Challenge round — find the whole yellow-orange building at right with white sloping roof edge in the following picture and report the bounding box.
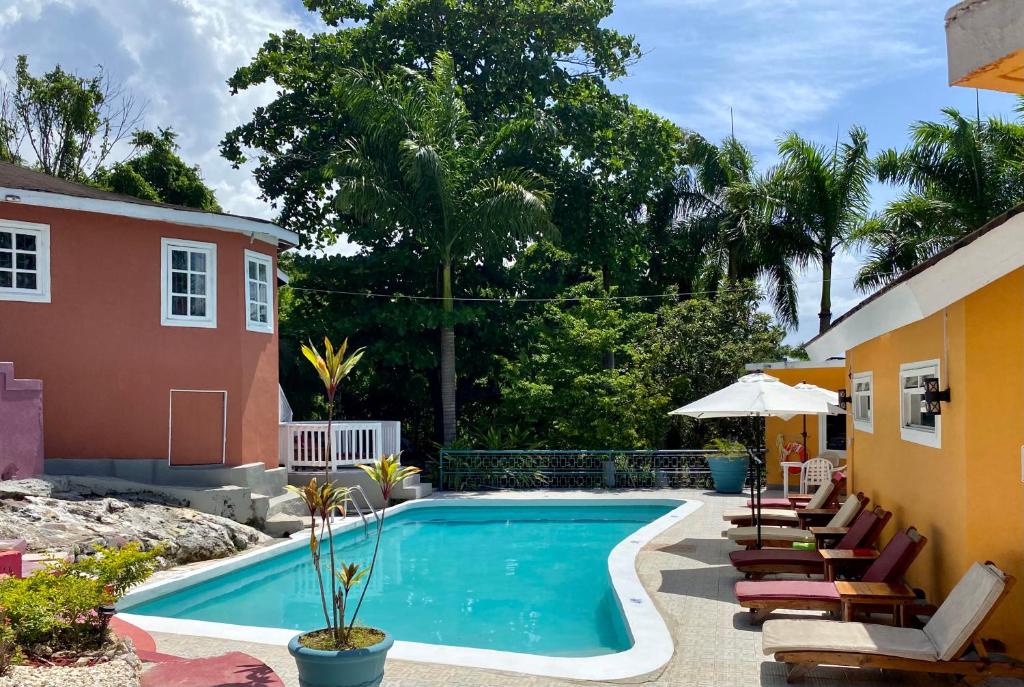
[807,208,1024,654]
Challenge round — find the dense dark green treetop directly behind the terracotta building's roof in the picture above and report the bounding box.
[94,129,220,212]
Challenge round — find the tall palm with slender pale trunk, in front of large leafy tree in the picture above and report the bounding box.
[332,52,553,445]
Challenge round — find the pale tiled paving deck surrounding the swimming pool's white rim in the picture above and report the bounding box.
[153,489,1021,687]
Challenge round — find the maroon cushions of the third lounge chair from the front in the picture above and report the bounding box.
[729,507,892,579]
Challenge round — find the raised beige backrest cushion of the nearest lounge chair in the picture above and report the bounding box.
[924,563,1007,660]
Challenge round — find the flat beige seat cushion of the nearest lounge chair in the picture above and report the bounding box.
[761,619,939,662]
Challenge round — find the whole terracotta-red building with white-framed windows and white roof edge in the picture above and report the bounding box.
[0,164,297,467]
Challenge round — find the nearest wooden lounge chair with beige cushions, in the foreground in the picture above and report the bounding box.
[761,563,1024,685]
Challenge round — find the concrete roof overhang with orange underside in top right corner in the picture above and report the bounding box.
[946,0,1024,93]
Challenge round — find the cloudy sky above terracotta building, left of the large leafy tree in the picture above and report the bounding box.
[0,0,317,218]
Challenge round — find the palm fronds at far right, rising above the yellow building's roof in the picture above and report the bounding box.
[856,107,1024,291]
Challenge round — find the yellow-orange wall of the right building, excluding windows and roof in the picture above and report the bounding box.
[847,270,1024,654]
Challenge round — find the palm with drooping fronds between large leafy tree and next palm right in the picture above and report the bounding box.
[677,134,809,327]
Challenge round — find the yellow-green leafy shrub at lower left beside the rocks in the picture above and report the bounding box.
[0,545,160,651]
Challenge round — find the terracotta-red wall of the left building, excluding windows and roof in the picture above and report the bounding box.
[0,203,278,467]
